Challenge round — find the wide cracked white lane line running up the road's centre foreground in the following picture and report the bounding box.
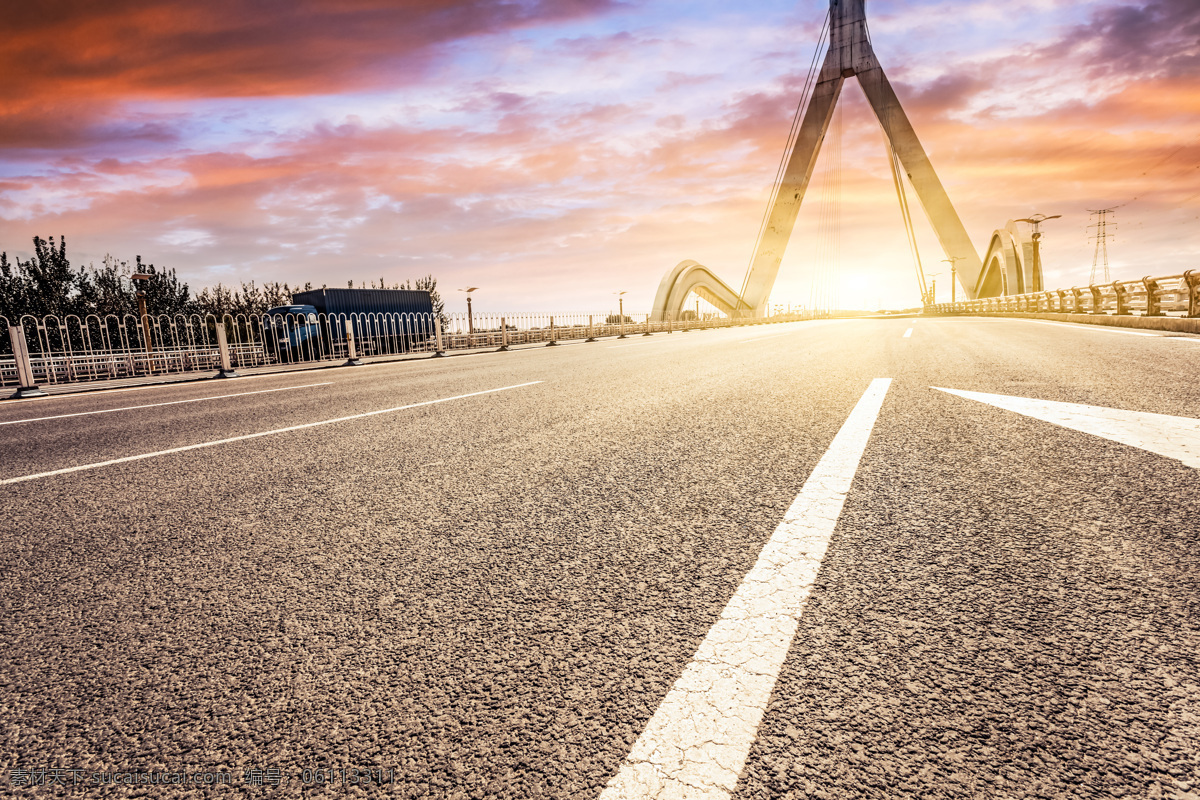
[600,378,892,800]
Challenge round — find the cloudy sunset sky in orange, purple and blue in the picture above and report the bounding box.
[0,0,1200,312]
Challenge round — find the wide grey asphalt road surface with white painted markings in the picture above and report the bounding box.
[0,318,1200,800]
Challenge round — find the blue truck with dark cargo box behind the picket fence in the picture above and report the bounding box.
[263,289,433,360]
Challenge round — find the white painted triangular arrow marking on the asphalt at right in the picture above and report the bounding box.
[930,386,1200,469]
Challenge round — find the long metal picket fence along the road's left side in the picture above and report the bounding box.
[0,313,812,387]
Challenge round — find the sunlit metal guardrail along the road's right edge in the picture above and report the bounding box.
[930,270,1200,317]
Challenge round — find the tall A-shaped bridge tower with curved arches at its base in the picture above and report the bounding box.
[654,0,1040,319]
